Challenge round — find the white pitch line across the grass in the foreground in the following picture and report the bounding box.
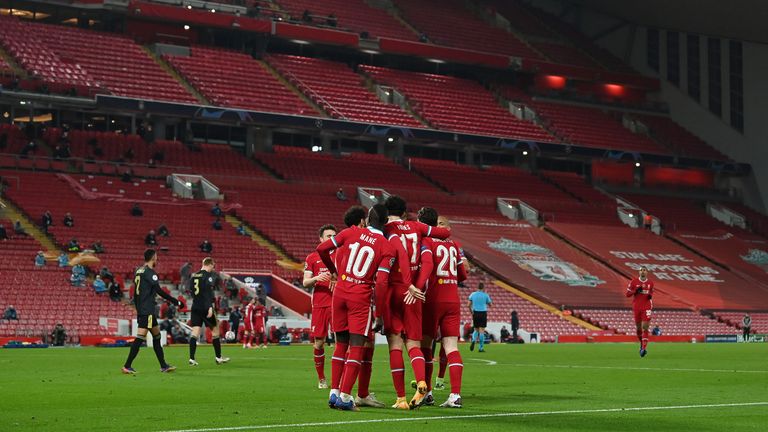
[158,402,768,432]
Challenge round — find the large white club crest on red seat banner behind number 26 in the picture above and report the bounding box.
[488,237,605,287]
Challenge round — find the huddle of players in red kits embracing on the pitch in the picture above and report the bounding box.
[304,196,466,410]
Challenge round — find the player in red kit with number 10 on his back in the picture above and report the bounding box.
[317,205,397,410]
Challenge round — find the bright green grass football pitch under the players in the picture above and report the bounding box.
[0,343,768,432]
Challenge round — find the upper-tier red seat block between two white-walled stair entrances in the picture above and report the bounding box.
[360,65,553,142]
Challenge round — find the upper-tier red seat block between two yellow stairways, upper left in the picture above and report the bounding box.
[164,46,312,116]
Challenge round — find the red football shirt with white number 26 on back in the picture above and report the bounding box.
[419,237,467,303]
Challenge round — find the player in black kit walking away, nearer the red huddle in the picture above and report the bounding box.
[189,257,229,366]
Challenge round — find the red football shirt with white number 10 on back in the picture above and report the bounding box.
[317,228,396,316]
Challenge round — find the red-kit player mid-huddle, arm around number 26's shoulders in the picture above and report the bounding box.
[384,195,451,409]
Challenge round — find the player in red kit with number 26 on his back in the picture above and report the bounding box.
[417,207,467,408]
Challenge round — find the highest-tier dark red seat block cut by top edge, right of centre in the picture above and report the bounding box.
[395,0,539,58]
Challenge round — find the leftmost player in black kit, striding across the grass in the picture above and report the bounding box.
[123,249,181,374]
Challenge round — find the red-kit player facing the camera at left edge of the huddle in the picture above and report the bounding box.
[303,225,336,389]
